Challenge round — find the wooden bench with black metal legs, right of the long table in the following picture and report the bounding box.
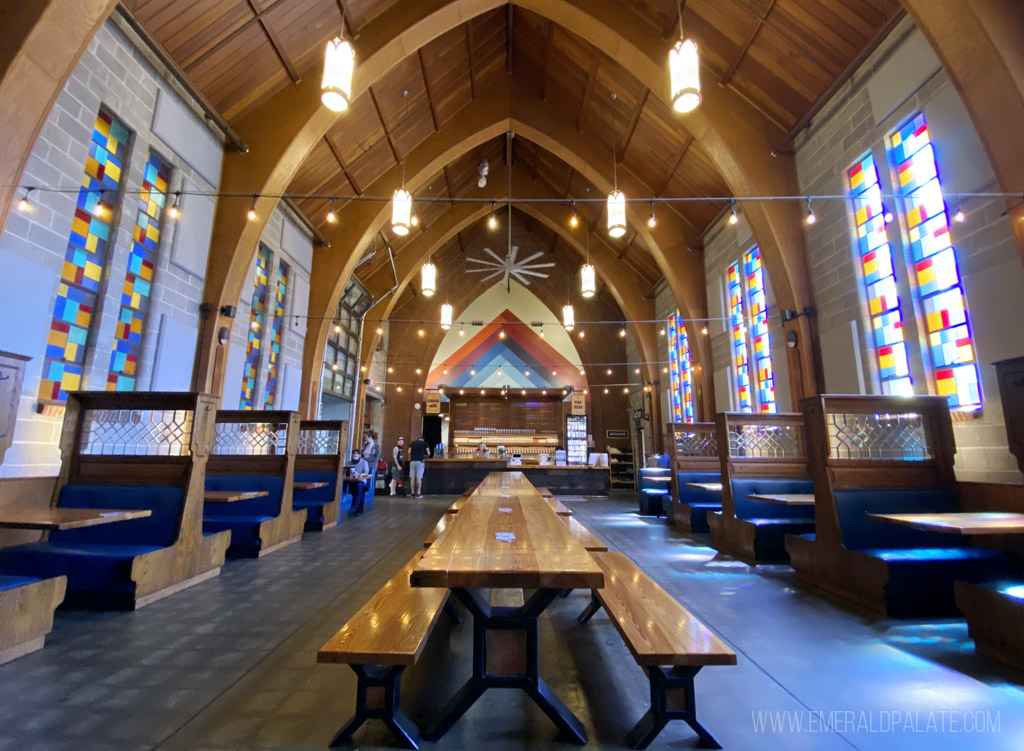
[578,552,736,748]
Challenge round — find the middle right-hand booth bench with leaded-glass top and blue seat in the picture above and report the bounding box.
[708,412,814,561]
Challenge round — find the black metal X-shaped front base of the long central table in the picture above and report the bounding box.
[424,589,587,745]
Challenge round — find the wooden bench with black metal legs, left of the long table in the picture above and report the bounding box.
[316,552,449,749]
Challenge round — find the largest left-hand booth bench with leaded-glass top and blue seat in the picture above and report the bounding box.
[29,391,229,610]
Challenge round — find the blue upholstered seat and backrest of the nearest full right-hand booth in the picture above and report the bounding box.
[834,489,1020,616]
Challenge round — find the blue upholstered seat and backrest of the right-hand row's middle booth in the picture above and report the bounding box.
[731,477,814,560]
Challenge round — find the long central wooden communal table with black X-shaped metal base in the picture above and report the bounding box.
[411,472,604,745]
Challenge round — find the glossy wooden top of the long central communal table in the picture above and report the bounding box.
[412,472,604,589]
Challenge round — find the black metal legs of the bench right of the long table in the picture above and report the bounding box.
[577,592,722,748]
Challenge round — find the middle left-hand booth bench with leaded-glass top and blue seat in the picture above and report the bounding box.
[203,410,306,557]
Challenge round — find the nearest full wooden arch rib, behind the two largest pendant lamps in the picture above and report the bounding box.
[192,0,820,397]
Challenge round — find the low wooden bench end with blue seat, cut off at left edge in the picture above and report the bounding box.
[0,575,68,665]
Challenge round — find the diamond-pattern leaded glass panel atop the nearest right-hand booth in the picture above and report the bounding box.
[825,413,934,461]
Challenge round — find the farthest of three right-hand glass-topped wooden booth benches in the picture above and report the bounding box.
[669,422,722,532]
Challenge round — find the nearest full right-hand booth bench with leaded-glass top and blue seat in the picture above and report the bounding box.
[786,395,1013,615]
